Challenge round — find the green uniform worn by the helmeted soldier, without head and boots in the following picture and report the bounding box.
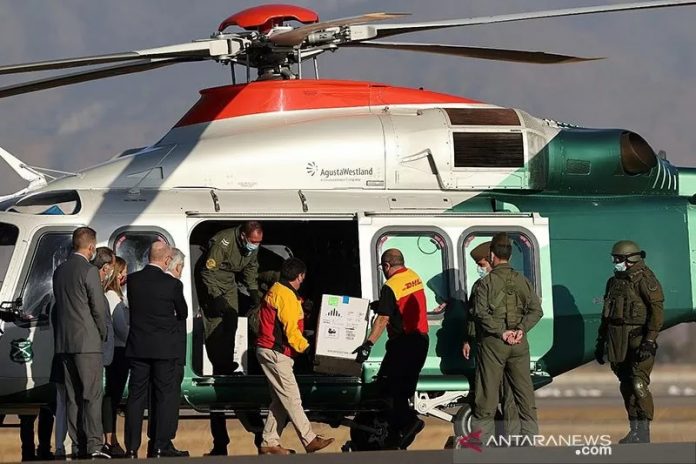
[597,261,664,421]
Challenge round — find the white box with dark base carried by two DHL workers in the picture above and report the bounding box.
[314,295,370,376]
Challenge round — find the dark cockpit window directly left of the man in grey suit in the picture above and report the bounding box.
[22,232,72,321]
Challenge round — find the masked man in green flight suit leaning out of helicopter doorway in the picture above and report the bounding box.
[201,221,263,456]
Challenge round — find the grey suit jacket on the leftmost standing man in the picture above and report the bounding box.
[53,253,108,354]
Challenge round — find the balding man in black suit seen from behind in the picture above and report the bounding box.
[125,242,188,457]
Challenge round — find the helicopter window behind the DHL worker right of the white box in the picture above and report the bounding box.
[376,231,449,314]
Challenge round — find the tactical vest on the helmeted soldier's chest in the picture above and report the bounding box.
[602,270,648,325]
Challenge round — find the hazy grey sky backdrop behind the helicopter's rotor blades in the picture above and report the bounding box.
[0,0,696,195]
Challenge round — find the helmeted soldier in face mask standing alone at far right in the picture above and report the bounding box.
[595,240,665,443]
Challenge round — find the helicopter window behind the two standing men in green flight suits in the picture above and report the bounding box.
[463,231,539,294]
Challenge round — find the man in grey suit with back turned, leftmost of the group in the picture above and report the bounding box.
[53,227,109,458]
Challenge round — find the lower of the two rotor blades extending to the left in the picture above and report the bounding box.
[0,57,201,98]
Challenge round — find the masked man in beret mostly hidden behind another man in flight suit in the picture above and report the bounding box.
[462,241,520,436]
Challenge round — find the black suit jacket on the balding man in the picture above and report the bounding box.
[126,265,188,359]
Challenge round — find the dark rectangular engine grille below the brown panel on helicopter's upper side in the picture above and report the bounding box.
[452,132,524,168]
